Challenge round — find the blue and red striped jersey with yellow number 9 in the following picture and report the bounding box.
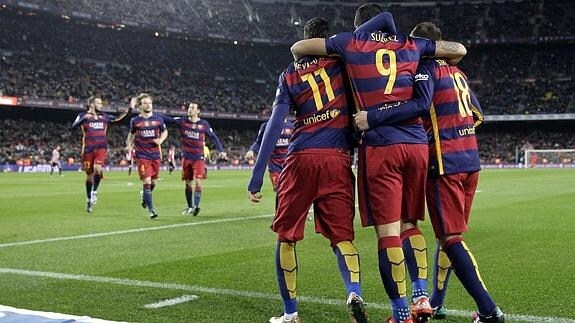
[326,31,435,146]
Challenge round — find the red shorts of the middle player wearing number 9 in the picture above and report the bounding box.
[358,144,428,227]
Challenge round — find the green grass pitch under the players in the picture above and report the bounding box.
[0,169,575,322]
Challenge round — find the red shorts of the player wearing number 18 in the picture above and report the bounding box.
[427,172,479,239]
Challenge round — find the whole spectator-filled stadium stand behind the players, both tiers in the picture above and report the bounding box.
[0,0,575,170]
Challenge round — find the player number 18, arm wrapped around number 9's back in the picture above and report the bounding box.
[358,22,505,323]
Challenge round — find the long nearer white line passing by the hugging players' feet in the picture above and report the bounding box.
[0,268,575,323]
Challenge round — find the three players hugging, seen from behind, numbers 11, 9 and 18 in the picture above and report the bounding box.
[246,4,505,323]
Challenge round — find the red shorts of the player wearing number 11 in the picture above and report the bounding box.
[271,149,355,244]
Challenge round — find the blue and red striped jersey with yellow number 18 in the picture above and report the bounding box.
[416,59,483,175]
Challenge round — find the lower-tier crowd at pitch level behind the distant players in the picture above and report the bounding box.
[0,119,575,166]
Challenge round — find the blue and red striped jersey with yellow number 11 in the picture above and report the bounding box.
[274,57,350,152]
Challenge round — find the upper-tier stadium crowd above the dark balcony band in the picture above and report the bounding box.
[0,1,575,114]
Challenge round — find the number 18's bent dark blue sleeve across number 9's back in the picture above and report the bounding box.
[367,60,435,128]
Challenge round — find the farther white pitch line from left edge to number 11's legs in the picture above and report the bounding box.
[0,214,273,248]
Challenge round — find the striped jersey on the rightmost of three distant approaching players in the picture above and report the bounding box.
[164,116,224,160]
